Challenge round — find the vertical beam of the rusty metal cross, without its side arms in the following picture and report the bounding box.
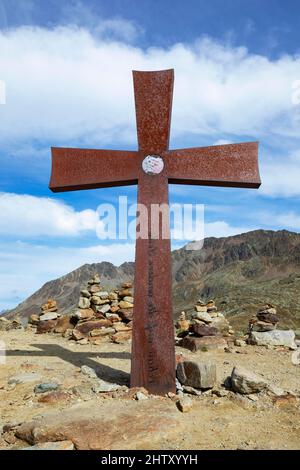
[130,70,176,395]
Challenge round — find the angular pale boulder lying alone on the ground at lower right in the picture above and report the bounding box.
[231,367,268,394]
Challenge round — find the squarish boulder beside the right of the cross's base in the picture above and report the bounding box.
[176,361,217,389]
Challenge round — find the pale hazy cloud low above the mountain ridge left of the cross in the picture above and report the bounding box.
[0,242,134,311]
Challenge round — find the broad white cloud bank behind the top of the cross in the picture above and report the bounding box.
[0,26,300,145]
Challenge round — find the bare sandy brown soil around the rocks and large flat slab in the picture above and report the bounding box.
[0,330,300,449]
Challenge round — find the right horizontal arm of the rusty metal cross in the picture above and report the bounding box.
[163,142,261,188]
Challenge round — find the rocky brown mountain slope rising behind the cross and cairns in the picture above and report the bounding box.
[7,230,300,330]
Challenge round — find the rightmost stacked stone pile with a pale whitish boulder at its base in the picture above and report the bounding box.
[248,303,297,349]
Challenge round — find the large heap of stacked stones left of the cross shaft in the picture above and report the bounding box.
[29,274,134,344]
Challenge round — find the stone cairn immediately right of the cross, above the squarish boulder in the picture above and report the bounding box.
[175,300,234,351]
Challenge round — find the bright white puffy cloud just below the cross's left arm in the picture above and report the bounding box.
[0,193,101,238]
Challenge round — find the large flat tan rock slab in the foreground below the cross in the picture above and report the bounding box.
[15,400,184,451]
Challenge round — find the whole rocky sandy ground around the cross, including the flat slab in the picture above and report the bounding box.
[0,329,300,449]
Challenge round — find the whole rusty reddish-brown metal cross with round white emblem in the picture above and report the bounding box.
[50,70,260,395]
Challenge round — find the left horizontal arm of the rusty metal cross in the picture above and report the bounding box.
[49,147,138,192]
